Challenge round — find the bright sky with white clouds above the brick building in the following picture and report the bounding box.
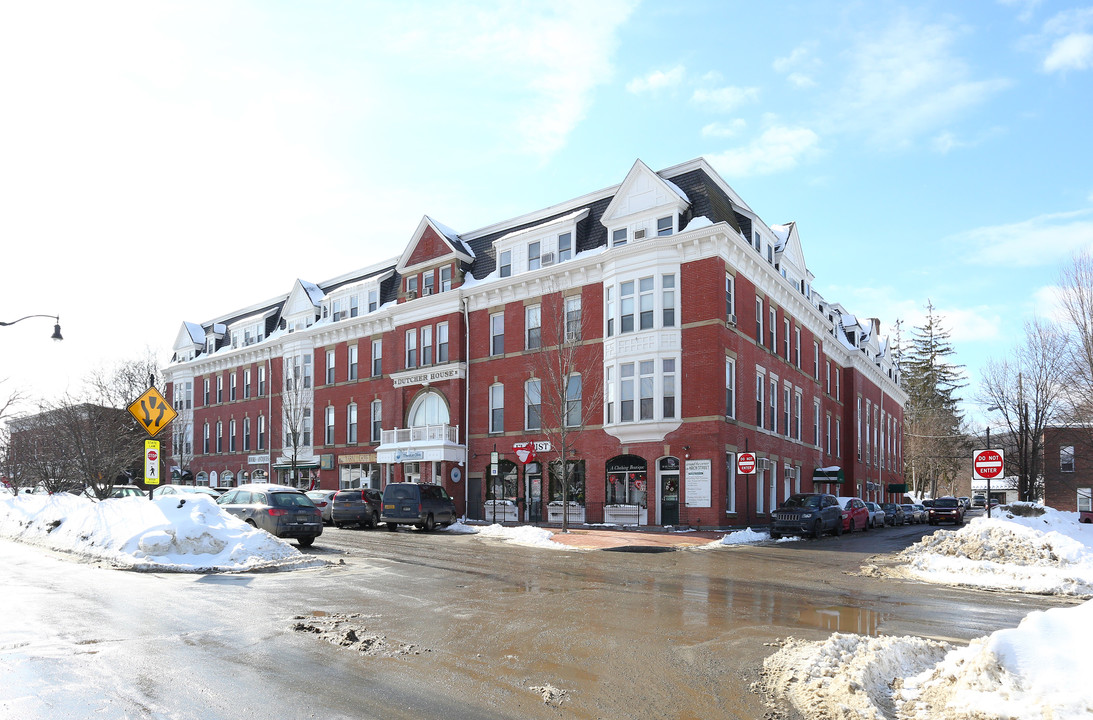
[0,0,1093,421]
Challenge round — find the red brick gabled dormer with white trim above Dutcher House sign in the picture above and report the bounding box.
[395,215,474,302]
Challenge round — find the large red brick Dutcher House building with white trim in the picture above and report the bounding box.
[166,160,906,527]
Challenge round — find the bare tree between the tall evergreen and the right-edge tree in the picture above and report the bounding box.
[977,320,1069,501]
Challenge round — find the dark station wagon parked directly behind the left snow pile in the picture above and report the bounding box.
[216,483,322,547]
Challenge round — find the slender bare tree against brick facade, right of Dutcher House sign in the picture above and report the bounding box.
[524,292,603,532]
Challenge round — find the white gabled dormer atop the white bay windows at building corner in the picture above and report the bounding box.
[600,160,691,247]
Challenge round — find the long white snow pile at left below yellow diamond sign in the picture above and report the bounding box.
[0,493,325,573]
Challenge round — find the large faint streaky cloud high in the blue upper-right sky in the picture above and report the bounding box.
[827,14,1010,147]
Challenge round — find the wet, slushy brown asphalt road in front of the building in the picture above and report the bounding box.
[0,509,1073,720]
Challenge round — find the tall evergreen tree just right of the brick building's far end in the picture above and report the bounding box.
[898,302,967,497]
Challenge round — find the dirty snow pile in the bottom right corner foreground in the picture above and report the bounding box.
[757,601,1093,720]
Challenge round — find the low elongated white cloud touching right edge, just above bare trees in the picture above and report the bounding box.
[948,210,1093,268]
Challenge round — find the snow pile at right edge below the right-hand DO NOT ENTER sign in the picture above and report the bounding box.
[889,503,1093,597]
